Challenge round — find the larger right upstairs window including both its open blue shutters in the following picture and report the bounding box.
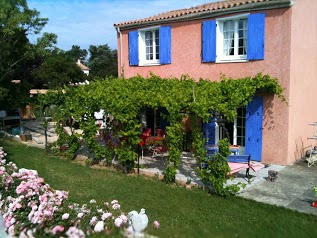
[202,13,265,62]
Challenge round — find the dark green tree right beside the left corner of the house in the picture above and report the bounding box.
[88,44,118,78]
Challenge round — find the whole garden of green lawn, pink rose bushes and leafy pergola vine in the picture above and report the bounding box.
[1,74,308,237]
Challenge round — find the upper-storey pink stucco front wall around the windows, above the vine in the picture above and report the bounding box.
[118,9,290,80]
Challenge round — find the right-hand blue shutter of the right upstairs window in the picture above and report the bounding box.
[247,13,265,60]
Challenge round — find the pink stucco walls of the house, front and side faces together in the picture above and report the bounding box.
[118,6,317,164]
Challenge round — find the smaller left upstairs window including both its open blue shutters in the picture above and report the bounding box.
[129,26,171,66]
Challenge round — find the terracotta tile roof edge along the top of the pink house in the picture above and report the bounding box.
[114,0,291,27]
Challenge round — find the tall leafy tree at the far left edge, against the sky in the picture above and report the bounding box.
[0,0,47,109]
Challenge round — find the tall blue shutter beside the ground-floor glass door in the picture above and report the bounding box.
[245,97,263,161]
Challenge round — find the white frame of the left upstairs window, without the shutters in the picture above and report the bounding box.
[139,26,160,66]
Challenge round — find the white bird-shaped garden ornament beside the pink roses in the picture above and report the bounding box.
[128,208,149,237]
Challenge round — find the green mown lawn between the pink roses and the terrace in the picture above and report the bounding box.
[0,139,317,238]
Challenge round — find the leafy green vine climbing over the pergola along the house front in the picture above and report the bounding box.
[42,74,285,190]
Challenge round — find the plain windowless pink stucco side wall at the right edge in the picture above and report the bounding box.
[288,0,317,163]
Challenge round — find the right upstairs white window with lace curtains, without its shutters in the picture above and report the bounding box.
[216,18,248,61]
